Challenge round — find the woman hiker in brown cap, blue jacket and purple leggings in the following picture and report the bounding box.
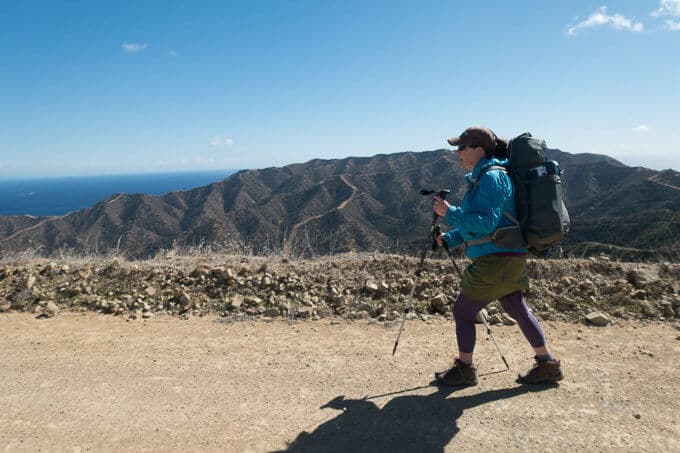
[434,127,564,386]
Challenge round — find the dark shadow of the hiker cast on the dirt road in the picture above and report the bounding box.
[274,386,552,452]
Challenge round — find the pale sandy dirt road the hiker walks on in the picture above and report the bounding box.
[0,313,680,451]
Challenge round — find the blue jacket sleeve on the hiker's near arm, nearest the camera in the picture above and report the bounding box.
[445,170,512,237]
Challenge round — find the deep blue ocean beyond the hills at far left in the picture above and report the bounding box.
[0,170,237,217]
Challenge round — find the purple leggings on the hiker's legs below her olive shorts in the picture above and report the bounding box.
[453,291,545,353]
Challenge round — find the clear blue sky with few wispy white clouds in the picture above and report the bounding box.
[0,0,680,179]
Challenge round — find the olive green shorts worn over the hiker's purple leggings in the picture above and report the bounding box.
[462,255,529,301]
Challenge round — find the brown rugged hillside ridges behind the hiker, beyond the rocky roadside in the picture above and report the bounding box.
[0,150,680,260]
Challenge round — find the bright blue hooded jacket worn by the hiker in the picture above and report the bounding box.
[444,157,527,259]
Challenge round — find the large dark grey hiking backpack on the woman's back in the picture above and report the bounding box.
[507,132,570,256]
